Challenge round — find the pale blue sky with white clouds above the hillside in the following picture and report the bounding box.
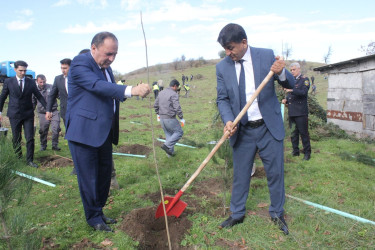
[0,0,375,83]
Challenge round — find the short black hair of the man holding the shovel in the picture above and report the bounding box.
[217,23,247,47]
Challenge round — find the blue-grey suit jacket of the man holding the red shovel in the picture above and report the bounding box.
[216,47,294,146]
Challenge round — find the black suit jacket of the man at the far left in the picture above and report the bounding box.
[0,77,47,119]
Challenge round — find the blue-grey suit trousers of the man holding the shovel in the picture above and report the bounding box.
[230,124,285,219]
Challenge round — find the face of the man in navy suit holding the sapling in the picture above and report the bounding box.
[91,38,118,68]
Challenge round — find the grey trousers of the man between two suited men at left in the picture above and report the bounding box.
[38,110,61,148]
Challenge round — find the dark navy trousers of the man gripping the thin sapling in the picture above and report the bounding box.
[69,132,112,226]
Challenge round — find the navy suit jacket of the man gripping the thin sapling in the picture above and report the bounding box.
[65,53,127,147]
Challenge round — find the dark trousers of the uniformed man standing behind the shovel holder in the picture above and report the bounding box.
[289,115,311,155]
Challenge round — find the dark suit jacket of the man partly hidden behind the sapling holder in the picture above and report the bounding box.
[47,74,68,120]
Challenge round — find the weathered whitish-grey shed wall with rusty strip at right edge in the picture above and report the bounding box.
[327,60,375,138]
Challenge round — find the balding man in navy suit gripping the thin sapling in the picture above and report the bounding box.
[65,32,151,232]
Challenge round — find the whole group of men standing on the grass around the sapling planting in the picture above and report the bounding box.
[0,23,311,234]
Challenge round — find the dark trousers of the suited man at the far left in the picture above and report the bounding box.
[9,116,35,162]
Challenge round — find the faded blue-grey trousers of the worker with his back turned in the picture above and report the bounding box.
[160,118,184,152]
